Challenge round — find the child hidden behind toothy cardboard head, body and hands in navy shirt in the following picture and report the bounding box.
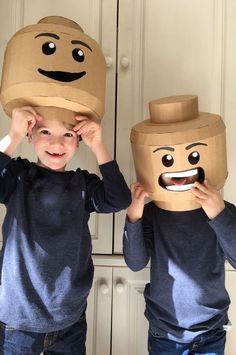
[123,181,236,355]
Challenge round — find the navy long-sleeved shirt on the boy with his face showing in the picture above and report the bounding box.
[0,153,130,333]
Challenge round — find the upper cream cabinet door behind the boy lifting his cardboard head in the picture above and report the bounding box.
[0,0,117,254]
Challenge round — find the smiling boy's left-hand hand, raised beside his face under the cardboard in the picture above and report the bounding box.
[9,106,41,139]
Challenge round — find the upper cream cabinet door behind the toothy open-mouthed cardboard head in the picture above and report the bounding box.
[115,0,229,253]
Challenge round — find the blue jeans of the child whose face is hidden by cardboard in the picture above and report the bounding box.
[148,328,226,355]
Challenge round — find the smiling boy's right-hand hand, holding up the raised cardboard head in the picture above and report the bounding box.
[73,116,102,149]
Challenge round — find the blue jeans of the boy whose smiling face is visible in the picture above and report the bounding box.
[0,315,87,355]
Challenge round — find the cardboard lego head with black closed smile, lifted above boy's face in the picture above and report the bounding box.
[1,16,106,124]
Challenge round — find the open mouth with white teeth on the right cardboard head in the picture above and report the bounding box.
[159,168,205,191]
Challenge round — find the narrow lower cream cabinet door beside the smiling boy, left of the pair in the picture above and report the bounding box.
[86,266,112,355]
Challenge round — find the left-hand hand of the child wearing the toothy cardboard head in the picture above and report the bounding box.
[127,182,148,223]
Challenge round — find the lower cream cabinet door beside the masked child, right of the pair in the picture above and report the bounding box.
[112,268,150,355]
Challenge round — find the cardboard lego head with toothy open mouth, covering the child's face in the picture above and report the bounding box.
[131,95,227,211]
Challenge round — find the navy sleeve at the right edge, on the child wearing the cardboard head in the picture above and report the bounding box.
[208,202,236,268]
